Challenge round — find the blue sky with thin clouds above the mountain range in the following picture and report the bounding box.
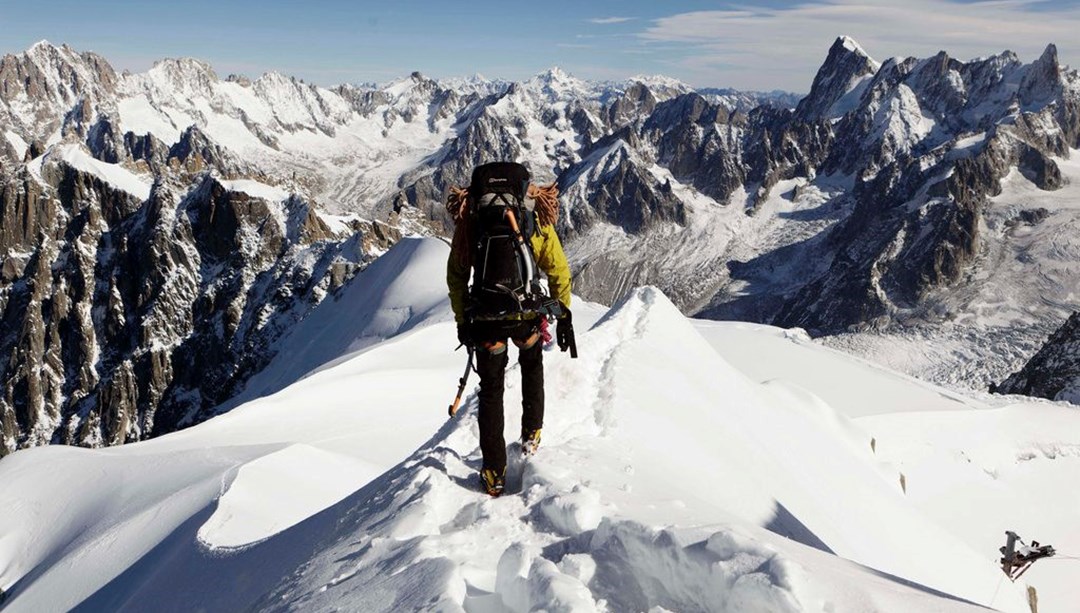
[0,0,1080,92]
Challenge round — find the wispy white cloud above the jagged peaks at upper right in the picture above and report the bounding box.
[639,0,1080,92]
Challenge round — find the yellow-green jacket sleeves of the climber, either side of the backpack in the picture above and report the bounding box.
[446,221,570,324]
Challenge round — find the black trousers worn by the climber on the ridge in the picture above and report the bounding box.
[473,322,543,473]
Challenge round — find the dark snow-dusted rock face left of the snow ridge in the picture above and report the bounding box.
[0,162,397,454]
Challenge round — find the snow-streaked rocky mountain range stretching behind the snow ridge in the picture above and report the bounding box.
[0,38,1080,454]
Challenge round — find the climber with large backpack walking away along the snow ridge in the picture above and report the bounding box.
[446,162,577,496]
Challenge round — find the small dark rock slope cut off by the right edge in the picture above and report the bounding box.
[990,313,1080,405]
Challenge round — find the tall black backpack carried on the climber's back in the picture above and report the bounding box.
[469,162,551,319]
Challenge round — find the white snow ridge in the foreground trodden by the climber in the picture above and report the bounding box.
[0,240,1080,612]
